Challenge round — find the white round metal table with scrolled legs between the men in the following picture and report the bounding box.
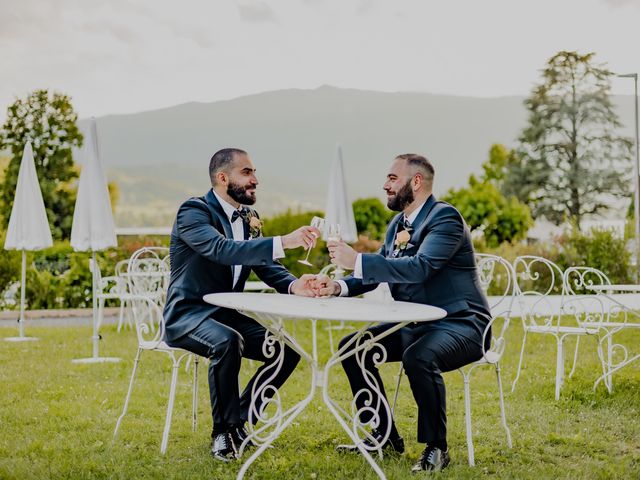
[204,293,446,479]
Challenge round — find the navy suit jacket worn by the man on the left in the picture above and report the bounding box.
[164,190,296,342]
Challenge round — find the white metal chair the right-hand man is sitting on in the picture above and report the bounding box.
[458,254,515,466]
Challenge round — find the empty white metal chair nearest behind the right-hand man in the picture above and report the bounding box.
[511,255,593,400]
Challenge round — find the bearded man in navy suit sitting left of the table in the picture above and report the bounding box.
[164,148,320,461]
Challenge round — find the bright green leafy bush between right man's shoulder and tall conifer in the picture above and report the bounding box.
[442,144,533,247]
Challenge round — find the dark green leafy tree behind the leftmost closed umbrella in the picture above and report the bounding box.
[0,90,82,239]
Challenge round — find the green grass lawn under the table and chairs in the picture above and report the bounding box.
[0,320,640,480]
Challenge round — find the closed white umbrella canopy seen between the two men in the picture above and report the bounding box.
[323,145,358,243]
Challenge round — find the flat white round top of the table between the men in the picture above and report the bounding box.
[204,292,447,322]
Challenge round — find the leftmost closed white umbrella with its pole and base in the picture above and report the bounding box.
[4,142,53,341]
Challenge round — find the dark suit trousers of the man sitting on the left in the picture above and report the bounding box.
[170,308,300,429]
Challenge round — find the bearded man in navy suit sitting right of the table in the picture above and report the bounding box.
[317,154,491,472]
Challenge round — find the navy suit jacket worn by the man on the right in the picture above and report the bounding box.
[345,195,491,335]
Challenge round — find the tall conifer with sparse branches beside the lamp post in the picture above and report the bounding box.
[505,51,631,226]
